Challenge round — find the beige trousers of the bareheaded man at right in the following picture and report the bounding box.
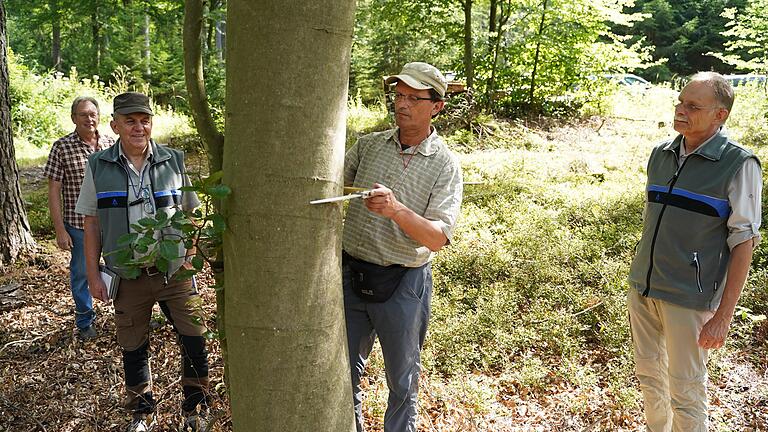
[627,288,714,432]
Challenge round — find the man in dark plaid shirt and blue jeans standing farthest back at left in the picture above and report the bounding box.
[45,96,115,340]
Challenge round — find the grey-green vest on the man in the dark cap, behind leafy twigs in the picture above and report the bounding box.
[88,140,186,277]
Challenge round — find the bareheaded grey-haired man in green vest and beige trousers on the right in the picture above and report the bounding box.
[628,72,762,432]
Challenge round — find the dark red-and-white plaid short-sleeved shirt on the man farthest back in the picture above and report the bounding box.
[44,132,115,229]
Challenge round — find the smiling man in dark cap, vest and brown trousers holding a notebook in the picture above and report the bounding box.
[75,92,208,432]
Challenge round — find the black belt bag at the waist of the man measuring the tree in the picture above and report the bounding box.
[342,252,410,303]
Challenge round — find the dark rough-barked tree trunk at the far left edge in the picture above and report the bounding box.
[0,0,35,270]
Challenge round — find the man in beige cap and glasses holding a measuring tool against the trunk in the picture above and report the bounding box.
[342,62,462,432]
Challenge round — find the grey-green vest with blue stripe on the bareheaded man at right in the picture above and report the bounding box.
[629,133,759,310]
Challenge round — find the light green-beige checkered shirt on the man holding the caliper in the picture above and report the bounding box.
[342,129,462,267]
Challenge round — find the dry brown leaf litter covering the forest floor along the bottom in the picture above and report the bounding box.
[0,129,768,432]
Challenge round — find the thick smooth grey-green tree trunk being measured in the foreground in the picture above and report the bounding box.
[224,0,355,432]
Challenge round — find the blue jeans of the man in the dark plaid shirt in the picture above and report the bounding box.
[64,224,96,329]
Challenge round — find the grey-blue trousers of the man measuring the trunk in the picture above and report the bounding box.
[342,264,432,432]
